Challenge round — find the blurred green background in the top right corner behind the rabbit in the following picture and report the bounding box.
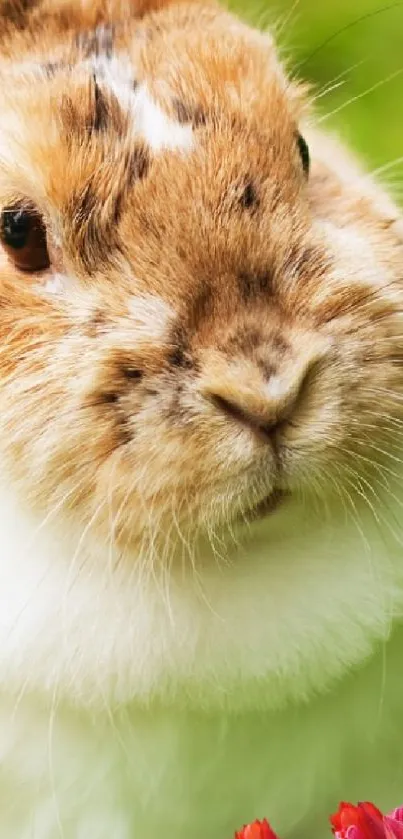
[229,0,403,187]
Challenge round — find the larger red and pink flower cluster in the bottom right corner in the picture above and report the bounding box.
[330,801,403,839]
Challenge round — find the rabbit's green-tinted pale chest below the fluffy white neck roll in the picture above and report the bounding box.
[0,636,403,839]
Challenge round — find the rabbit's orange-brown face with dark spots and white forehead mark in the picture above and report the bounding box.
[0,7,403,556]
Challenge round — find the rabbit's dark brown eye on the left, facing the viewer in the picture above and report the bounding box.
[0,205,49,272]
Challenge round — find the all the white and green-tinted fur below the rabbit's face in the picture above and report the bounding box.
[0,475,403,839]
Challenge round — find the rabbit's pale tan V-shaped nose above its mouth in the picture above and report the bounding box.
[202,348,318,442]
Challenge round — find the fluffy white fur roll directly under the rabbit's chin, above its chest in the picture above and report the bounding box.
[0,466,403,709]
